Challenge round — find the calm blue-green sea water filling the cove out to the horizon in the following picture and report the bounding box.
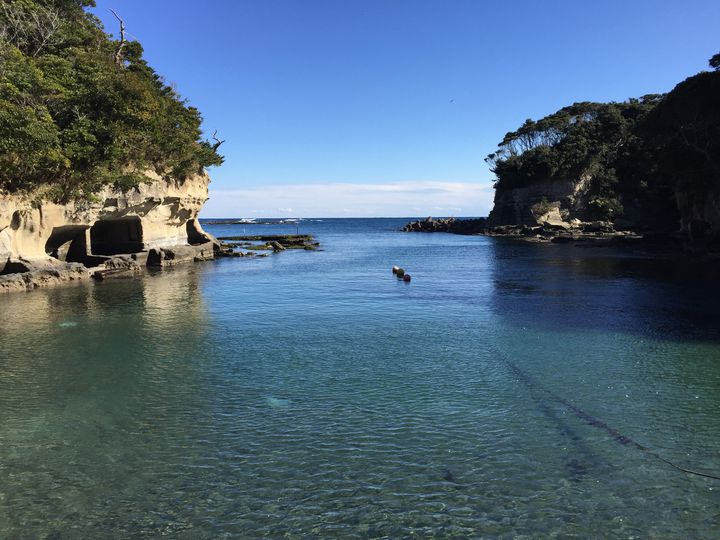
[0,219,720,538]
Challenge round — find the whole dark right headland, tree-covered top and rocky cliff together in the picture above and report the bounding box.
[486,63,720,253]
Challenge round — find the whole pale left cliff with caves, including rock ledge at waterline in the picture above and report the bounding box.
[0,173,216,290]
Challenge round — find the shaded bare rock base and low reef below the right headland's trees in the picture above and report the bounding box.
[402,177,720,254]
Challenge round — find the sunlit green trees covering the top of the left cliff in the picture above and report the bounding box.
[0,0,222,201]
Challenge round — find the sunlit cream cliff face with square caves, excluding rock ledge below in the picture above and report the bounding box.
[0,173,214,284]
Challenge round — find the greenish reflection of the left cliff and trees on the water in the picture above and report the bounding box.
[0,268,219,537]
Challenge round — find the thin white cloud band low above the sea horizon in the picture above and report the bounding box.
[202,181,493,218]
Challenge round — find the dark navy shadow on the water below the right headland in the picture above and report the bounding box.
[488,239,720,342]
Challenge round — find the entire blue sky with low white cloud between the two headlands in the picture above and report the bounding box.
[94,0,720,217]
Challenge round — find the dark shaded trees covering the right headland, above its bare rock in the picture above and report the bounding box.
[486,53,720,224]
